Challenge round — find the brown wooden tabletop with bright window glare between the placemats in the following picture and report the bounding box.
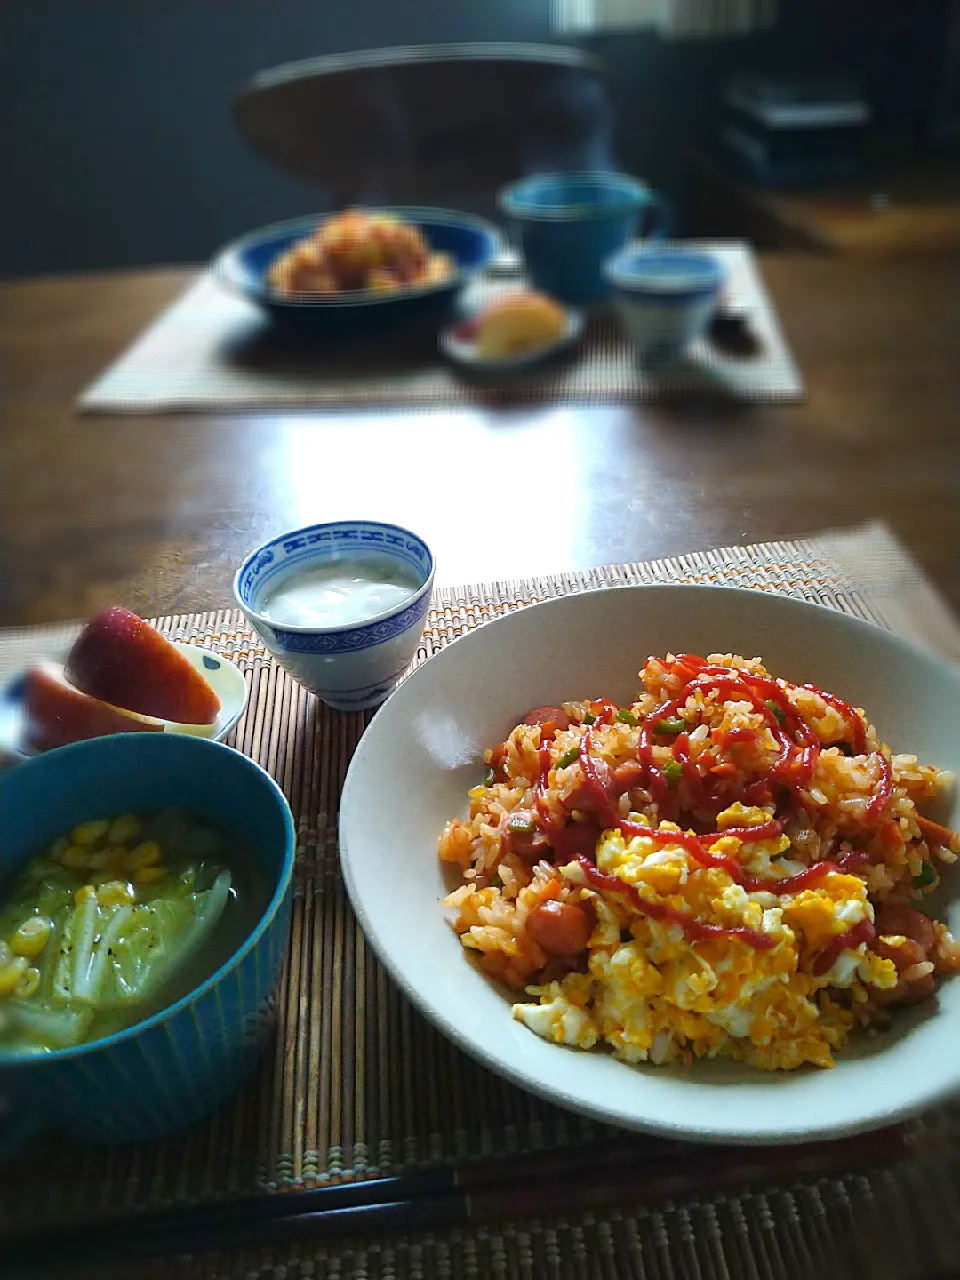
[0,255,960,626]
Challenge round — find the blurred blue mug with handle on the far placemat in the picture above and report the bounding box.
[499,173,667,306]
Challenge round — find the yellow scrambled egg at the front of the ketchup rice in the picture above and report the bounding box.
[513,805,897,1070]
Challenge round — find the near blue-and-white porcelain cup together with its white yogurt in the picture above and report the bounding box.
[233,520,434,710]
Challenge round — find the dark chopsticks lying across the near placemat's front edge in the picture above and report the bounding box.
[0,1126,913,1276]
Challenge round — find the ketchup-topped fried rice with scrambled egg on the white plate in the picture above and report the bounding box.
[439,654,960,1070]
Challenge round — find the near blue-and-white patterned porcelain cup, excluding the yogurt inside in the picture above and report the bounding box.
[233,520,435,712]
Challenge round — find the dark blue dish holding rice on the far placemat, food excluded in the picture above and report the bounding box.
[212,207,500,337]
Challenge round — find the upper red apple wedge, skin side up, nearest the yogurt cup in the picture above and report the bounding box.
[67,604,220,724]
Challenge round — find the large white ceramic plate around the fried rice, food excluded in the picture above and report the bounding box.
[340,586,960,1143]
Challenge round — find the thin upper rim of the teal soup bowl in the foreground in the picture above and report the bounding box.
[0,733,297,1070]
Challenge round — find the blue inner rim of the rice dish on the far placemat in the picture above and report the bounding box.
[211,205,503,311]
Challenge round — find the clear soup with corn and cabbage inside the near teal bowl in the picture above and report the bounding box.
[0,808,269,1053]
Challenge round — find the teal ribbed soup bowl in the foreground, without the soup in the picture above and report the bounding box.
[0,733,294,1155]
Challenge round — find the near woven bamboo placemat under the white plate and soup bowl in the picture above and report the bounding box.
[0,526,960,1280]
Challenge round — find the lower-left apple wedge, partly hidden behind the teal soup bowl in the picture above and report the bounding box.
[23,662,164,751]
